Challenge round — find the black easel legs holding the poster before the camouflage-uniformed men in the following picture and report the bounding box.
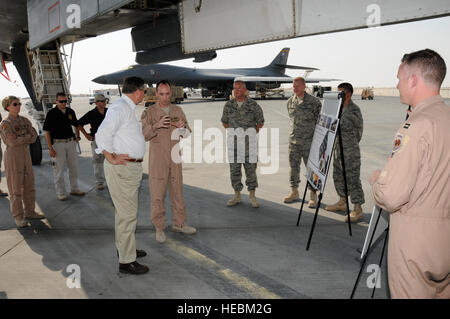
[297,91,352,250]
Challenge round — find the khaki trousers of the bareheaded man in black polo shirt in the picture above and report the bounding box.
[53,140,79,195]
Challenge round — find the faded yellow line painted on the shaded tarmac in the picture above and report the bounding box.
[166,238,281,299]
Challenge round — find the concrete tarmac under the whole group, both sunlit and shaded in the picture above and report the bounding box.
[0,96,448,299]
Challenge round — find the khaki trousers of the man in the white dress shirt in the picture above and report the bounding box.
[104,160,142,264]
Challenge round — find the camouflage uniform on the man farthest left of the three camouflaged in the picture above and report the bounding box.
[221,97,264,192]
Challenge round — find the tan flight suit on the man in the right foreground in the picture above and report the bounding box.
[372,95,450,299]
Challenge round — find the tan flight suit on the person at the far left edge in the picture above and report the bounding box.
[0,115,37,219]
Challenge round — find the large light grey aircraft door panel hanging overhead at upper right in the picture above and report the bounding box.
[179,0,450,54]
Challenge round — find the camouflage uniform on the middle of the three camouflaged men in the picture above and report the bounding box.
[287,92,322,188]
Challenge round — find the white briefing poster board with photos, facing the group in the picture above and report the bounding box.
[305,92,342,193]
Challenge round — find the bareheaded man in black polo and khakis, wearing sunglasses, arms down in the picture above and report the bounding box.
[44,93,85,200]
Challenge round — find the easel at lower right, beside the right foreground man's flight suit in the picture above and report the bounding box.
[350,206,389,299]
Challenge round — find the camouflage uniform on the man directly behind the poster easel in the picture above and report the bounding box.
[333,100,364,205]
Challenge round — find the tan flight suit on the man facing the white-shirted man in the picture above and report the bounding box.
[141,103,191,231]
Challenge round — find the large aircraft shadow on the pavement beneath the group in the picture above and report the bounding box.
[0,157,385,298]
